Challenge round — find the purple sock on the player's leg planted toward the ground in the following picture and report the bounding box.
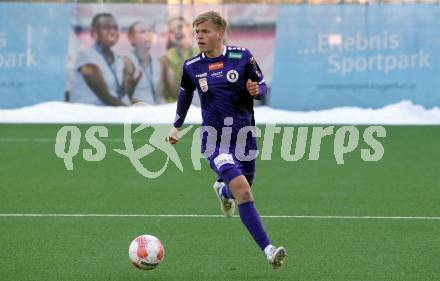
[238,201,270,250]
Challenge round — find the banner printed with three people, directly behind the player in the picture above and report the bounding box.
[66,4,277,106]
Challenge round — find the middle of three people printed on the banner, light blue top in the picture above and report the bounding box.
[127,21,164,105]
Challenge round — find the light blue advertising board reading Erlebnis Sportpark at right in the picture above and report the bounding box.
[270,4,440,110]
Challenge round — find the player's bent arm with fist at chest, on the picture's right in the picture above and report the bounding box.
[245,52,267,100]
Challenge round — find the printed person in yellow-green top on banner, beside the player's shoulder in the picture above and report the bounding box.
[161,17,199,102]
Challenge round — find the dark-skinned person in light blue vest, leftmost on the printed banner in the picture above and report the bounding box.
[70,13,142,106]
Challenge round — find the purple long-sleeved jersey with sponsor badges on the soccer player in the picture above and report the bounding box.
[174,46,267,153]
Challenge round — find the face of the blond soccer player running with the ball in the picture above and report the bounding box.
[196,21,223,53]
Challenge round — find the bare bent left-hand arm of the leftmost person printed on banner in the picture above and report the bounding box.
[80,64,126,106]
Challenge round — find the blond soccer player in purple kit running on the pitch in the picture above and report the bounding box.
[168,11,286,268]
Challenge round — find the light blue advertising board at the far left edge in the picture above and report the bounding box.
[0,3,73,108]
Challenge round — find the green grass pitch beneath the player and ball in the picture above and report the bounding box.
[0,125,440,281]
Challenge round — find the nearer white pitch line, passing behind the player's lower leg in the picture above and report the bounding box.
[0,214,440,220]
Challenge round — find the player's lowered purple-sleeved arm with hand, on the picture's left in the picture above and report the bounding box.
[168,64,196,144]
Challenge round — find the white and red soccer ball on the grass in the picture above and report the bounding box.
[128,235,165,270]
